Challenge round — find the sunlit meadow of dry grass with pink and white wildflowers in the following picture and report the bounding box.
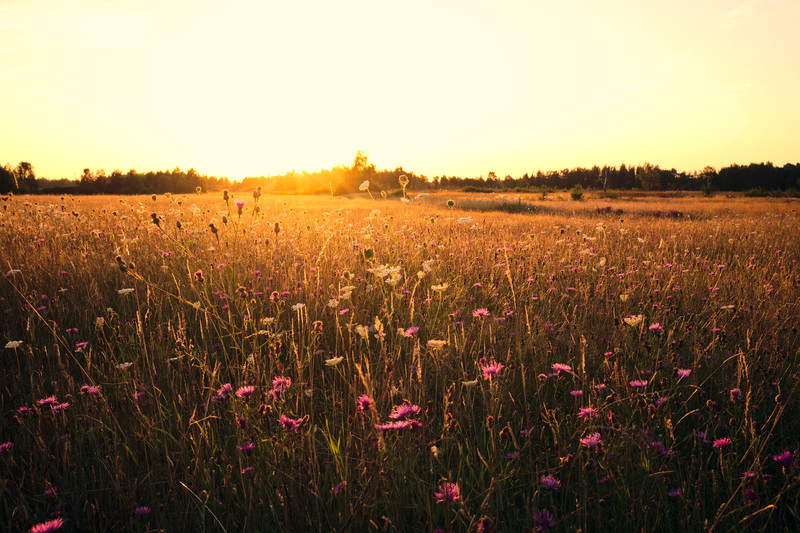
[0,190,800,532]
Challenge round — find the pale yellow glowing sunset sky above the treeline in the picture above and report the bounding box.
[0,0,800,179]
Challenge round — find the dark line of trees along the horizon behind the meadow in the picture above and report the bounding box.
[0,151,800,195]
